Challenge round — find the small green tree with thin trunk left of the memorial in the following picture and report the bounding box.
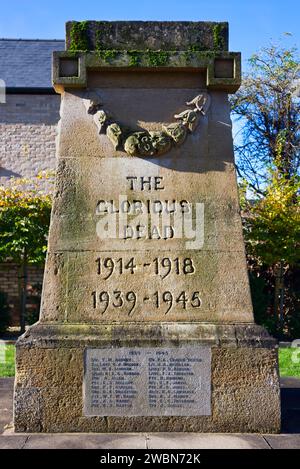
[0,179,51,332]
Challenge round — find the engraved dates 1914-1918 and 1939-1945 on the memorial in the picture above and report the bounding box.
[67,251,211,323]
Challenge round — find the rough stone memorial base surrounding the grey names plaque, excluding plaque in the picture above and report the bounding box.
[14,323,280,433]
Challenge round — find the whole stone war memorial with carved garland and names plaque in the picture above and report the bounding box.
[14,21,280,433]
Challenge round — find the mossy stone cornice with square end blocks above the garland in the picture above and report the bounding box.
[52,50,241,93]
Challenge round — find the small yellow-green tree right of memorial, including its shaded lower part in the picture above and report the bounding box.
[241,170,300,335]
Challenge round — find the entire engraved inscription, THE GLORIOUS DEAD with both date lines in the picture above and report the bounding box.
[66,167,206,323]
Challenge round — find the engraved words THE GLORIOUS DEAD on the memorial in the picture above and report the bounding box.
[94,168,204,250]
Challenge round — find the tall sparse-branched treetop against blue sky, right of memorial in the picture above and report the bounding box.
[231,39,300,195]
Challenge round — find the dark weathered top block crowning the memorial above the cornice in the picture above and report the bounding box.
[66,21,228,51]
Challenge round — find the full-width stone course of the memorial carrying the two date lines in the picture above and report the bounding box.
[41,250,252,324]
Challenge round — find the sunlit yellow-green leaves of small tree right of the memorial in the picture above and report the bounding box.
[241,170,300,266]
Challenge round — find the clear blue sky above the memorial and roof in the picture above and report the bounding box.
[0,0,300,61]
